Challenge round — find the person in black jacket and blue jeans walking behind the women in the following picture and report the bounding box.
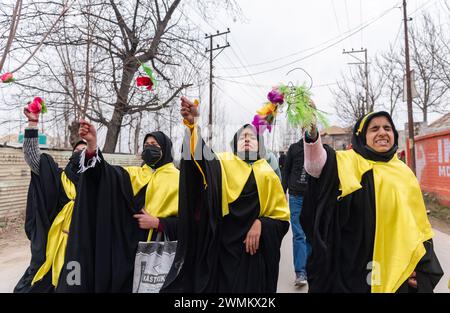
[282,139,309,286]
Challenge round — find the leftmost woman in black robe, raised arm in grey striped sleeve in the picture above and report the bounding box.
[14,108,86,293]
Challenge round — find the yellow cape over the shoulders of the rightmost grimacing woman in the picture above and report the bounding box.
[336,150,433,292]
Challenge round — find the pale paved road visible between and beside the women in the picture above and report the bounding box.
[0,225,450,293]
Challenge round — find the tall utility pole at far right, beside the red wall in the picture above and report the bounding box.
[403,0,416,174]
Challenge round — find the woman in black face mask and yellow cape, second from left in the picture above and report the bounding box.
[57,121,179,293]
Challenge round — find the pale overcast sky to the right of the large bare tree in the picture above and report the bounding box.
[187,0,445,128]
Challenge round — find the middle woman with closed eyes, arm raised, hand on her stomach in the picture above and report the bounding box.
[161,98,289,293]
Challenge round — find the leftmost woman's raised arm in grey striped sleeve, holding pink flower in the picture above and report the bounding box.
[23,107,41,175]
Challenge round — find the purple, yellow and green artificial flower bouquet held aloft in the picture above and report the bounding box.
[252,85,328,134]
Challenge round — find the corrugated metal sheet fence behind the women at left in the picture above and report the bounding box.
[0,147,142,219]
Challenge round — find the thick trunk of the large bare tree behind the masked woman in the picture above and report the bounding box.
[103,56,138,153]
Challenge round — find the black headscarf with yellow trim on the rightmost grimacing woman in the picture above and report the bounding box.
[352,111,398,162]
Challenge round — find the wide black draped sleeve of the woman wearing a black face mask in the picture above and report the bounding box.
[56,152,148,293]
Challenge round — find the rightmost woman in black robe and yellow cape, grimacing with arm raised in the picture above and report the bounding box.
[300,108,443,293]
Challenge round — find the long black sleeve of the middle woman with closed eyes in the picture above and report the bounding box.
[160,130,222,293]
